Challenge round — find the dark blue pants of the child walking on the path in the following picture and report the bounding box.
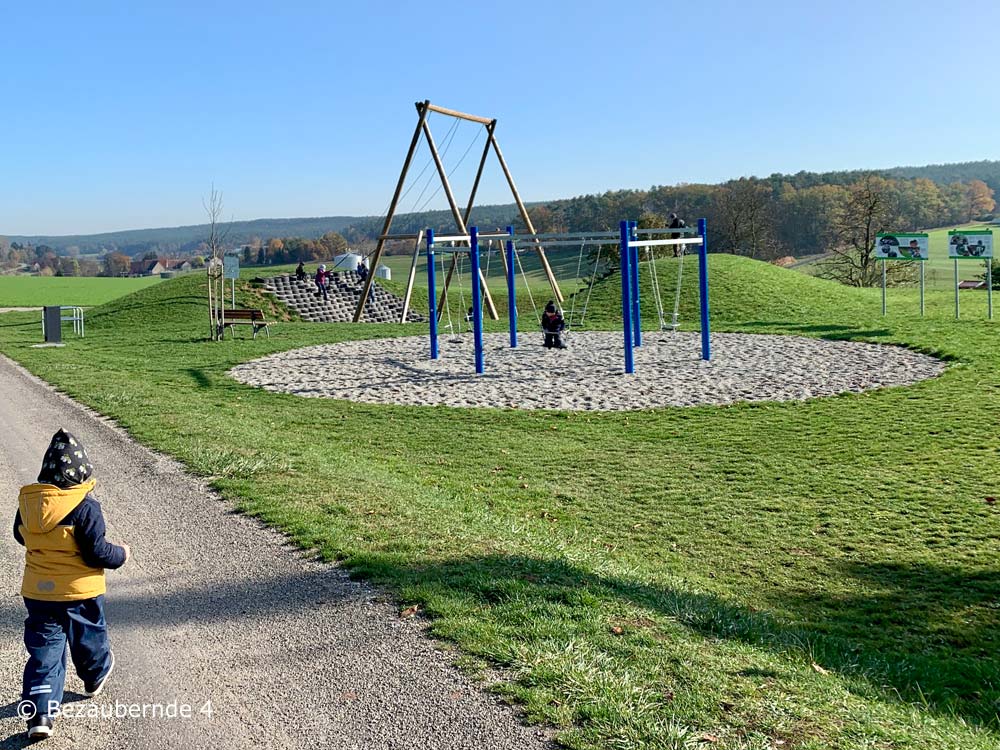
[21,595,111,714]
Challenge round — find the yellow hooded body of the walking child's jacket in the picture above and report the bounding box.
[18,480,106,602]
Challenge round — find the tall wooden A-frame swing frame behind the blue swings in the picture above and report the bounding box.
[354,99,563,323]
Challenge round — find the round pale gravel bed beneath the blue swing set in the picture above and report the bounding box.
[230,332,945,411]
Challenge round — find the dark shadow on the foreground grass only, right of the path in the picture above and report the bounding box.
[356,555,1000,730]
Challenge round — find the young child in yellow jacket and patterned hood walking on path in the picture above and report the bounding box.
[14,430,130,739]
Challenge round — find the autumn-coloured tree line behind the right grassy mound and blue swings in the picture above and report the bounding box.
[532,173,996,286]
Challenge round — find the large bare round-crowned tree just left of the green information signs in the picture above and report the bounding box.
[822,174,914,286]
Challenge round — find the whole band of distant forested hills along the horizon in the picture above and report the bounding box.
[0,161,1000,268]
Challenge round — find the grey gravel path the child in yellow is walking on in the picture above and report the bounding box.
[0,357,549,750]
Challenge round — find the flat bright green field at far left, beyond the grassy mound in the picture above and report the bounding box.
[0,276,160,307]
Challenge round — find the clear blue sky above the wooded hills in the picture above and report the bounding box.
[0,0,1000,234]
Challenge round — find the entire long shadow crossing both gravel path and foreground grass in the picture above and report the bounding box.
[0,555,984,731]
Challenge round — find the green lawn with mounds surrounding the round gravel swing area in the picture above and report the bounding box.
[0,255,1000,750]
